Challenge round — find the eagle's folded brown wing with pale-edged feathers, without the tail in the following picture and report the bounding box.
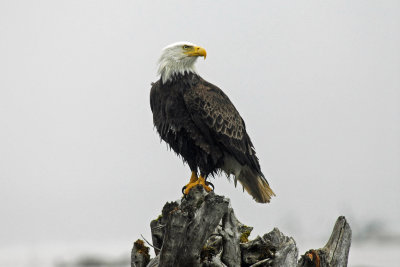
[184,79,263,176]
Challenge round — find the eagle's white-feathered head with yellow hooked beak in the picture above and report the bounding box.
[158,42,207,83]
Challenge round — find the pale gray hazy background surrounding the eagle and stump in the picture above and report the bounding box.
[0,0,400,267]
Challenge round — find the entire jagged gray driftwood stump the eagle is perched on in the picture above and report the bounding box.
[131,186,351,267]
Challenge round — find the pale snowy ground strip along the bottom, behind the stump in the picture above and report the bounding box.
[0,241,400,267]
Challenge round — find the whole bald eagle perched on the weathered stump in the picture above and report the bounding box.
[150,42,275,203]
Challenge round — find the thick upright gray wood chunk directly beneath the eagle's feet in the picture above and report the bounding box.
[159,186,229,267]
